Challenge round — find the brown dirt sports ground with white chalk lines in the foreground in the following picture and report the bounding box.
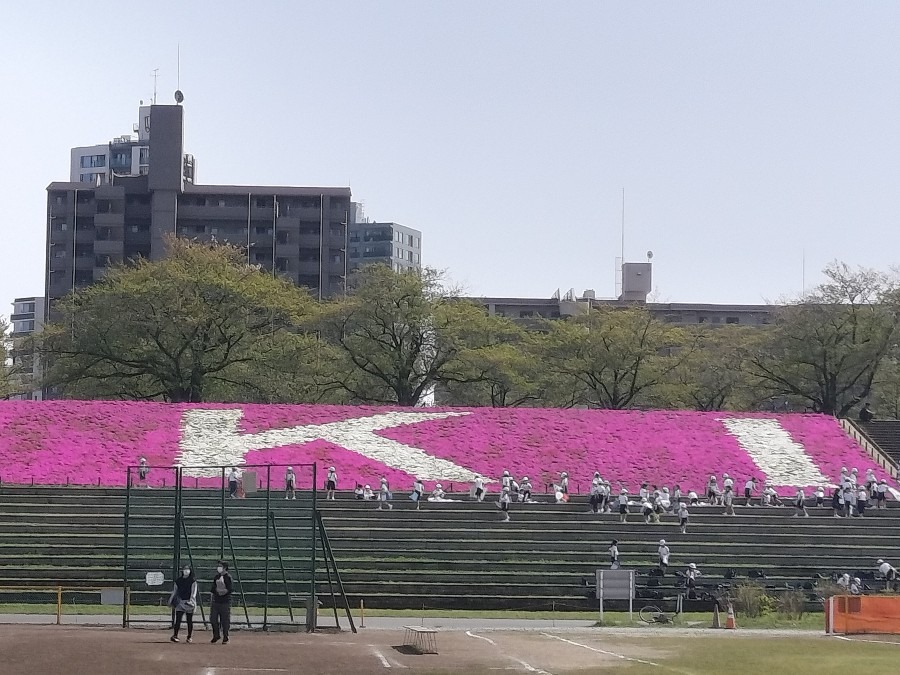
[0,625,900,675]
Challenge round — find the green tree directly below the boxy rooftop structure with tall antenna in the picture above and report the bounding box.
[543,307,691,409]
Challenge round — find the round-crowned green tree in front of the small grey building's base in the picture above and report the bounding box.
[322,265,500,406]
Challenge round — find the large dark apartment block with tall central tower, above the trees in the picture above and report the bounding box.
[45,105,350,317]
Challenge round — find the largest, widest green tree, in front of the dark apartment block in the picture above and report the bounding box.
[40,238,326,402]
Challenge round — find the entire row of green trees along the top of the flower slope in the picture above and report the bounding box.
[26,240,900,416]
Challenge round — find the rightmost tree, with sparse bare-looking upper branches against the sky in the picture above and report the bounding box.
[748,263,898,417]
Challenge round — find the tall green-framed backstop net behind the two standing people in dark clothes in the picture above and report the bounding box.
[122,464,317,629]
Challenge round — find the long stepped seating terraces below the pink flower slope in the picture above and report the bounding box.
[0,486,900,610]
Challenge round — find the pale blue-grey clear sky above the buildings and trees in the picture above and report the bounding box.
[0,0,900,314]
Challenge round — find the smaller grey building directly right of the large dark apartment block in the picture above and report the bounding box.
[348,202,422,272]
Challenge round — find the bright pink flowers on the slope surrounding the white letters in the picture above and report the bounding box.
[0,401,884,494]
